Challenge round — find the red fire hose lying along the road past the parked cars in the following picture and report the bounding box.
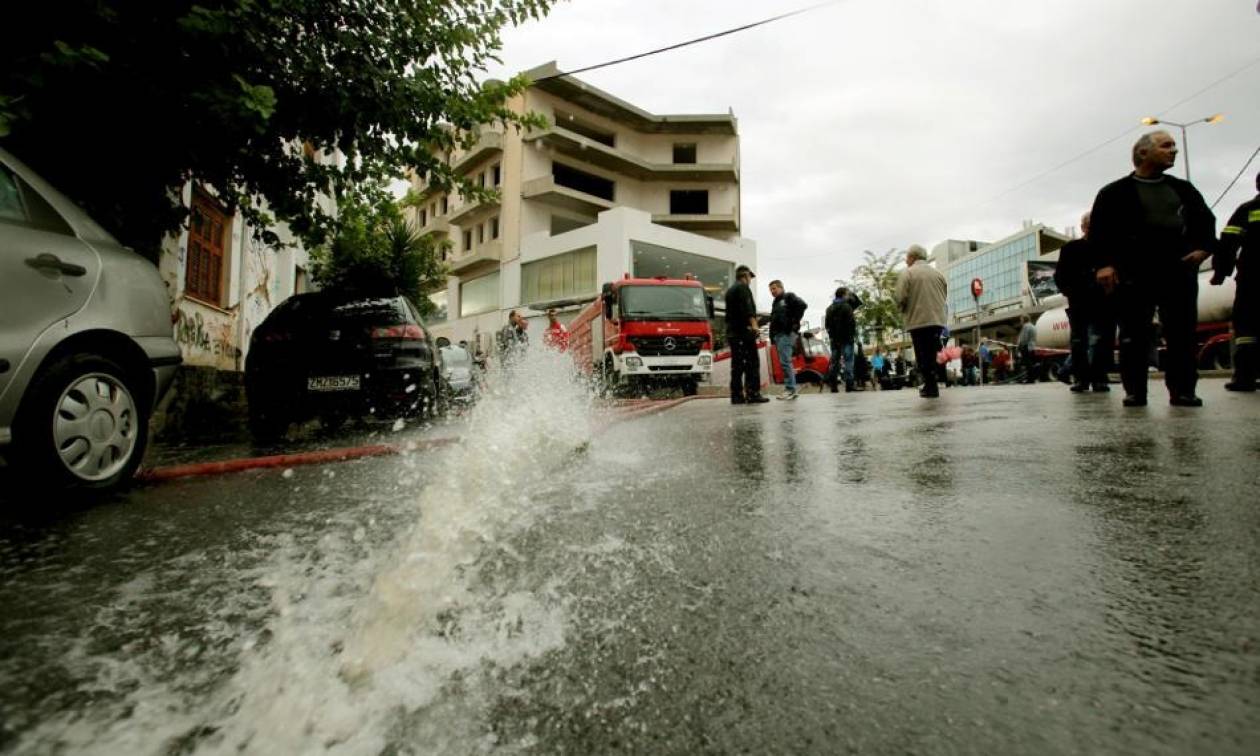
[135,396,719,483]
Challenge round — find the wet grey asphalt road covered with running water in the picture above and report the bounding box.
[0,381,1260,753]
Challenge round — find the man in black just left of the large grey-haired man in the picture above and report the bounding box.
[1055,213,1115,393]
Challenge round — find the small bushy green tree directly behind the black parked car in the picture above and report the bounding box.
[311,192,449,315]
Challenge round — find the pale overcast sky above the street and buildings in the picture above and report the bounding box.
[490,0,1260,312]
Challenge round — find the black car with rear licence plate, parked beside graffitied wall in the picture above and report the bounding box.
[244,292,444,441]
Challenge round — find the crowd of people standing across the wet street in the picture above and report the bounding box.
[726,131,1260,407]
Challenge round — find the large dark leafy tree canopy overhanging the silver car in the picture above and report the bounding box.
[0,0,556,252]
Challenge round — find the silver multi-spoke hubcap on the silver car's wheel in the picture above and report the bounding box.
[53,373,140,481]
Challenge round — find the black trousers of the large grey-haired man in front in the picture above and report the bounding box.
[1118,265,1198,397]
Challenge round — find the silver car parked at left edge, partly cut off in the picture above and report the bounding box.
[0,149,180,489]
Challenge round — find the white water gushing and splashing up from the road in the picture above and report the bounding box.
[24,348,593,753]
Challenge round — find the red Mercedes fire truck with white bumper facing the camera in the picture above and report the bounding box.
[568,273,713,396]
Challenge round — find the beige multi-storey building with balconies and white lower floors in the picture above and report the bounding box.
[412,62,756,350]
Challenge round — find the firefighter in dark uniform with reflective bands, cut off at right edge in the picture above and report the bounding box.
[1212,174,1260,391]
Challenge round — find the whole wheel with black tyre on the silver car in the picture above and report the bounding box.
[14,354,149,489]
